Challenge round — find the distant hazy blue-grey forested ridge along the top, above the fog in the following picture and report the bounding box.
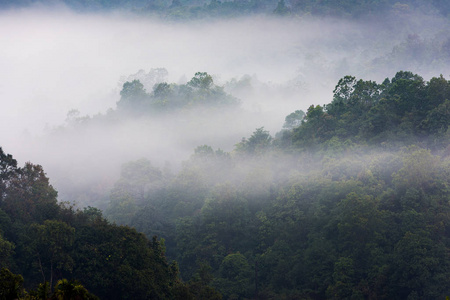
[0,0,450,20]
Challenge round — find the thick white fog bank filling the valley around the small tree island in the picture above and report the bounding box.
[0,8,450,205]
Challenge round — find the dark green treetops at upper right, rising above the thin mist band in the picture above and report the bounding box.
[285,72,450,150]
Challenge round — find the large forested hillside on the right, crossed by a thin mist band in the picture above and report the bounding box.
[106,71,450,299]
